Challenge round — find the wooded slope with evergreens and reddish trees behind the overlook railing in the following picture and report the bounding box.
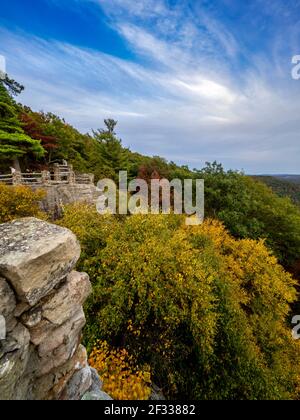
[0,78,191,180]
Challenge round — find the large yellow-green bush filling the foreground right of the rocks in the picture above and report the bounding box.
[61,206,300,399]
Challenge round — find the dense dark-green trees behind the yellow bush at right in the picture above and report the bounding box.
[197,163,300,269]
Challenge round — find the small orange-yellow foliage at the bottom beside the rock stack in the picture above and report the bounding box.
[89,341,151,400]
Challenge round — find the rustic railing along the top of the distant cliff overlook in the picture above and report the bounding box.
[0,164,94,186]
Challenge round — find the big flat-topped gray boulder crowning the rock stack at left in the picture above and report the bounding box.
[0,218,80,306]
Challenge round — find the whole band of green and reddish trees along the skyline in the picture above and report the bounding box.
[0,78,300,269]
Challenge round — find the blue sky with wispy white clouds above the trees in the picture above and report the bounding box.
[0,0,300,174]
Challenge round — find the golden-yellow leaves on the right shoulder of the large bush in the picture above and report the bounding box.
[188,219,296,317]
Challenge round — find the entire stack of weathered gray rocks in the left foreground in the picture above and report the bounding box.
[0,218,109,400]
